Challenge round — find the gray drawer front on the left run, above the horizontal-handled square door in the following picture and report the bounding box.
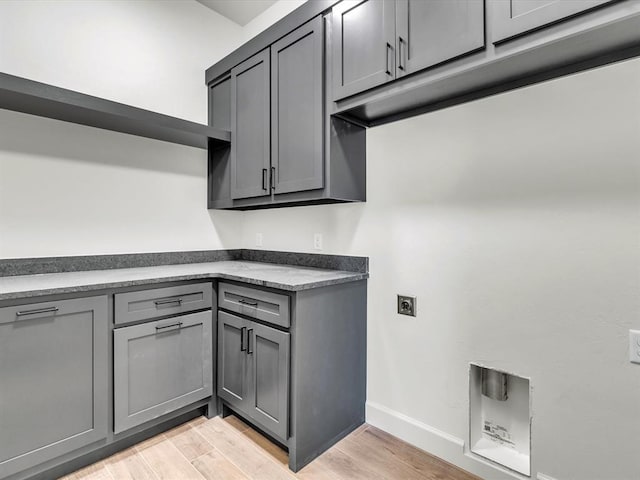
[115,283,212,324]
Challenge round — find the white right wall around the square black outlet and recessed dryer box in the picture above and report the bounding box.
[242,60,640,480]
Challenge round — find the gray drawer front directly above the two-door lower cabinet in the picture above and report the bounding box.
[218,283,291,327]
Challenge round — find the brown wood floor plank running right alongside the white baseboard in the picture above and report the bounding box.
[358,427,482,480]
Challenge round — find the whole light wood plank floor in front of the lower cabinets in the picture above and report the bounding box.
[63,416,479,480]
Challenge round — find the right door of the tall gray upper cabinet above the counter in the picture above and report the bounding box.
[271,17,324,194]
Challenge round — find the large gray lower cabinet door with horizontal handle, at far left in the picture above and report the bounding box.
[0,296,108,478]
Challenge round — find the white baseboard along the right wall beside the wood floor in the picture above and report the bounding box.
[366,402,528,480]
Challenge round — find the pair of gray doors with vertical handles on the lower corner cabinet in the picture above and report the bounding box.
[218,311,290,442]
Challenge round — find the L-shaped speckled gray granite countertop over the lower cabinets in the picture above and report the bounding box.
[0,261,369,301]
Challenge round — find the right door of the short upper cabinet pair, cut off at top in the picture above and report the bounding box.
[396,0,484,76]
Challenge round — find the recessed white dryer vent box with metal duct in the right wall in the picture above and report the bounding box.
[469,364,531,476]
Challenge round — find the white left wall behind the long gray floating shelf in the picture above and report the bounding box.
[0,0,243,258]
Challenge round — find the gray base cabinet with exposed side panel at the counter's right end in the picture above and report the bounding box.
[217,280,367,472]
